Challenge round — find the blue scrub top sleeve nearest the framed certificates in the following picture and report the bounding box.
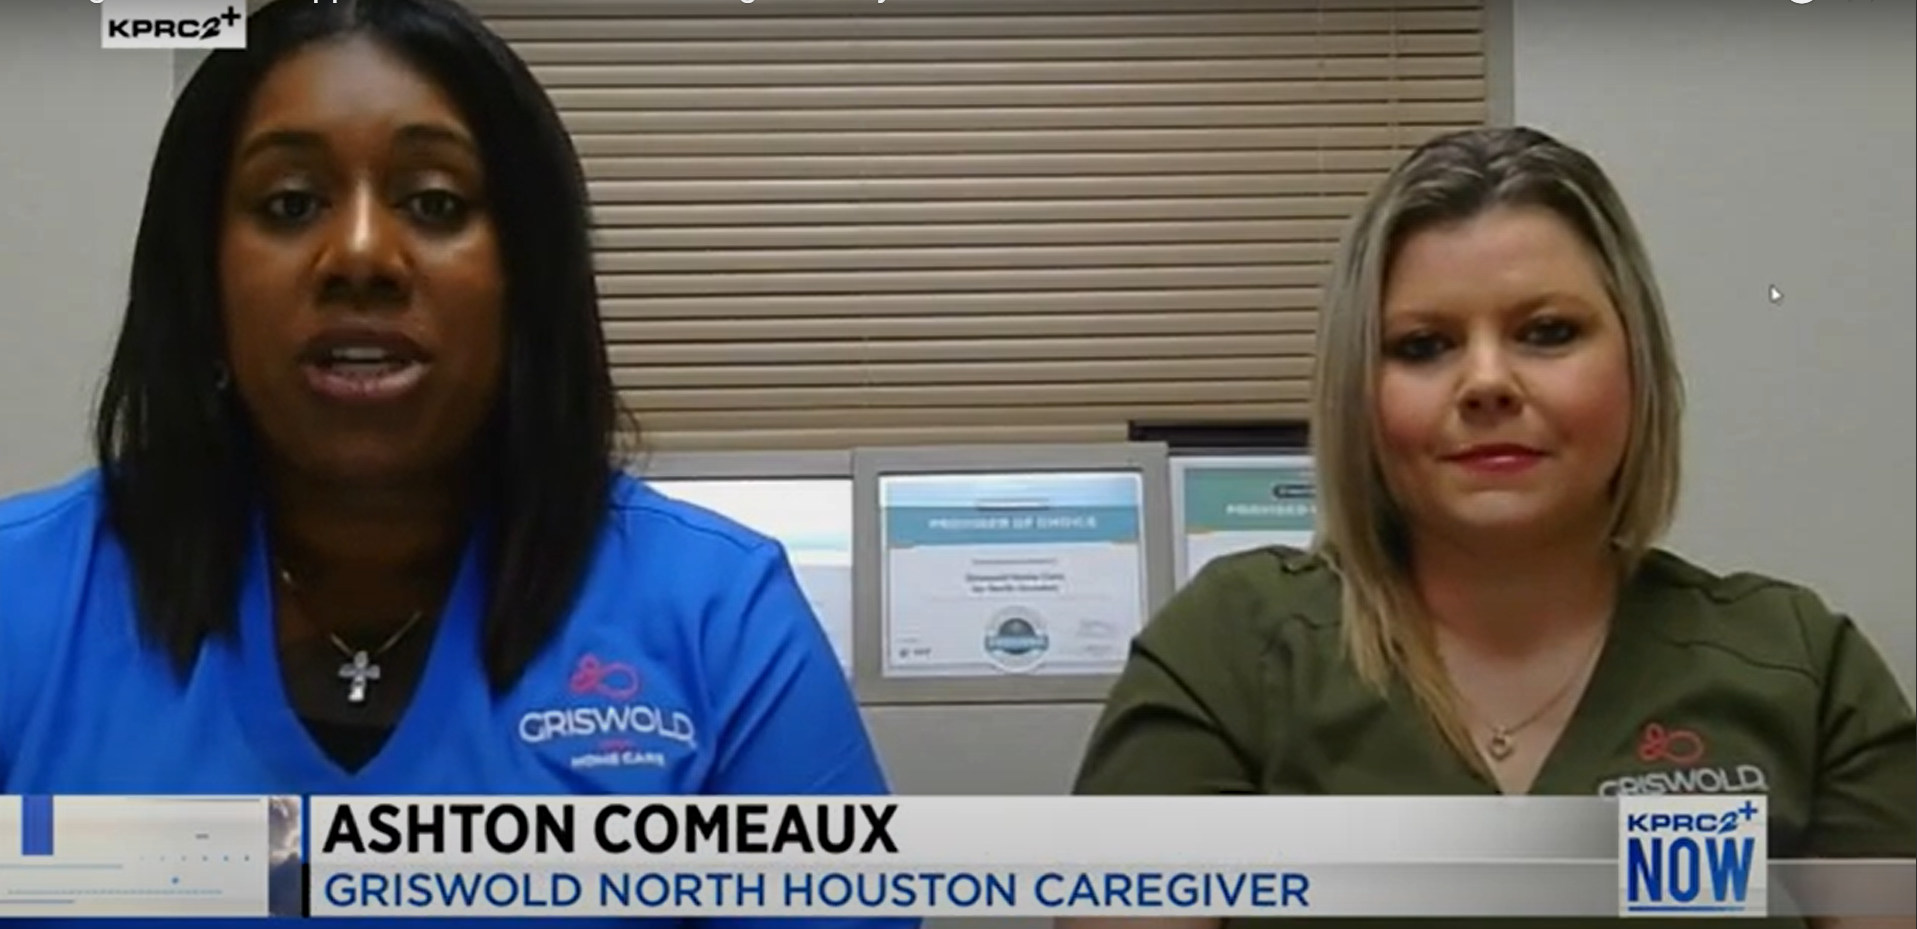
[698,542,920,929]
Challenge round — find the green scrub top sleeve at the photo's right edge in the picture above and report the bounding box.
[1806,603,1917,858]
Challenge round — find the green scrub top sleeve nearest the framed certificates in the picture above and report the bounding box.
[1074,555,1269,795]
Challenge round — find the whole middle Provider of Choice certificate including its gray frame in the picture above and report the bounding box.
[853,444,1169,703]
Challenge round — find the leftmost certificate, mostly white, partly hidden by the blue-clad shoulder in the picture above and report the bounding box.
[654,477,853,674]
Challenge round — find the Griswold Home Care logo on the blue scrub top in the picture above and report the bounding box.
[518,653,700,770]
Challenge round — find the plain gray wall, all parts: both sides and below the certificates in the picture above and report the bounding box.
[0,0,1917,819]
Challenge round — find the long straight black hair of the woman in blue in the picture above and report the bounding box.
[94,0,629,691]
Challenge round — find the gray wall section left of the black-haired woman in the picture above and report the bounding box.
[0,0,173,494]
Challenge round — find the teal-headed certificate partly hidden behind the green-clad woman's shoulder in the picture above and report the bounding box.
[1171,456,1317,584]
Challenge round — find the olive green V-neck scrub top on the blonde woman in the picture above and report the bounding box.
[1075,548,1917,929]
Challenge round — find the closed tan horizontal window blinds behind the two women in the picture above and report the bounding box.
[472,0,1486,450]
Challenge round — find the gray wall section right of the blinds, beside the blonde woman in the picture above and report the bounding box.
[1513,0,1917,690]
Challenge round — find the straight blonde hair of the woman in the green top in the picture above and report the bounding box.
[1311,128,1683,762]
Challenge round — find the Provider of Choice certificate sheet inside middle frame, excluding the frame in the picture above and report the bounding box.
[880,471,1146,678]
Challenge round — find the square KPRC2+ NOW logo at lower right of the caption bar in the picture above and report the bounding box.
[1618,795,1769,918]
